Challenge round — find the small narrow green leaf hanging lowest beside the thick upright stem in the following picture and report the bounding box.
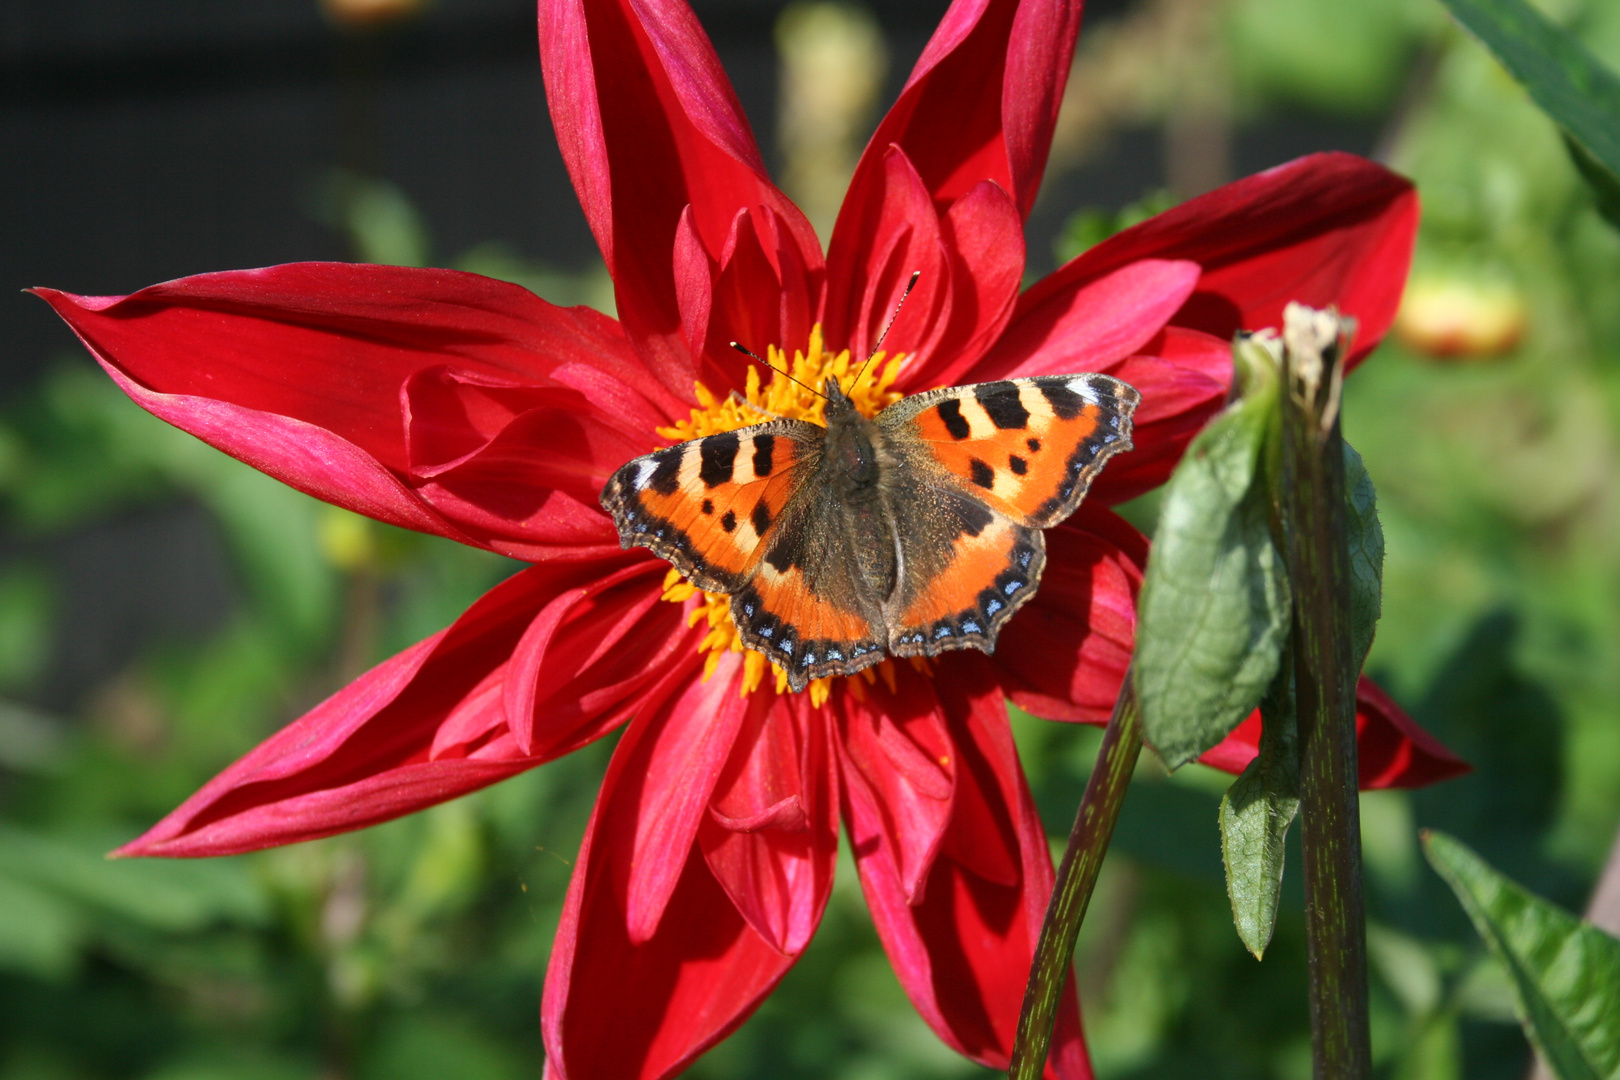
[1220,665,1299,960]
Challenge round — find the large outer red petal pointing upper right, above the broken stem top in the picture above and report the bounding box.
[1014,154,1418,363]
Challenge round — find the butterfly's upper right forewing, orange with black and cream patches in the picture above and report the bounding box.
[878,374,1142,529]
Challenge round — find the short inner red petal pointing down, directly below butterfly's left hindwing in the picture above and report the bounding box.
[698,693,838,955]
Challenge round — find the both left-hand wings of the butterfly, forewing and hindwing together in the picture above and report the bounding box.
[601,419,885,690]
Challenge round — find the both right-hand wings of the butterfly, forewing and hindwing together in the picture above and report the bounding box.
[876,374,1140,656]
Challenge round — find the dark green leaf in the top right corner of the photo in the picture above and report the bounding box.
[1443,0,1620,220]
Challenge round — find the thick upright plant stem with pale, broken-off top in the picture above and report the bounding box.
[1281,304,1372,1080]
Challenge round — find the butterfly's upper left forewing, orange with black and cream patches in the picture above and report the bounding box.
[601,419,823,593]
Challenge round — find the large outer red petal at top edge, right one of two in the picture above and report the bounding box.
[833,0,1081,220]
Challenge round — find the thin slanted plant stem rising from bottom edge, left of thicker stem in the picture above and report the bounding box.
[1008,670,1142,1080]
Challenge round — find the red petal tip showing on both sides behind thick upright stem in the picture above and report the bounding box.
[1199,675,1471,790]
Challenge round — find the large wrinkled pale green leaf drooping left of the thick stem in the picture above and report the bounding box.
[1132,347,1290,769]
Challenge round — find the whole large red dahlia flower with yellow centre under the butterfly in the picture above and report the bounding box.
[39,0,1460,1080]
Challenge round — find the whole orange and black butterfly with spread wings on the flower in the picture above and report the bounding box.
[601,374,1140,691]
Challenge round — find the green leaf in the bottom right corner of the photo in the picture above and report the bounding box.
[1422,832,1620,1080]
